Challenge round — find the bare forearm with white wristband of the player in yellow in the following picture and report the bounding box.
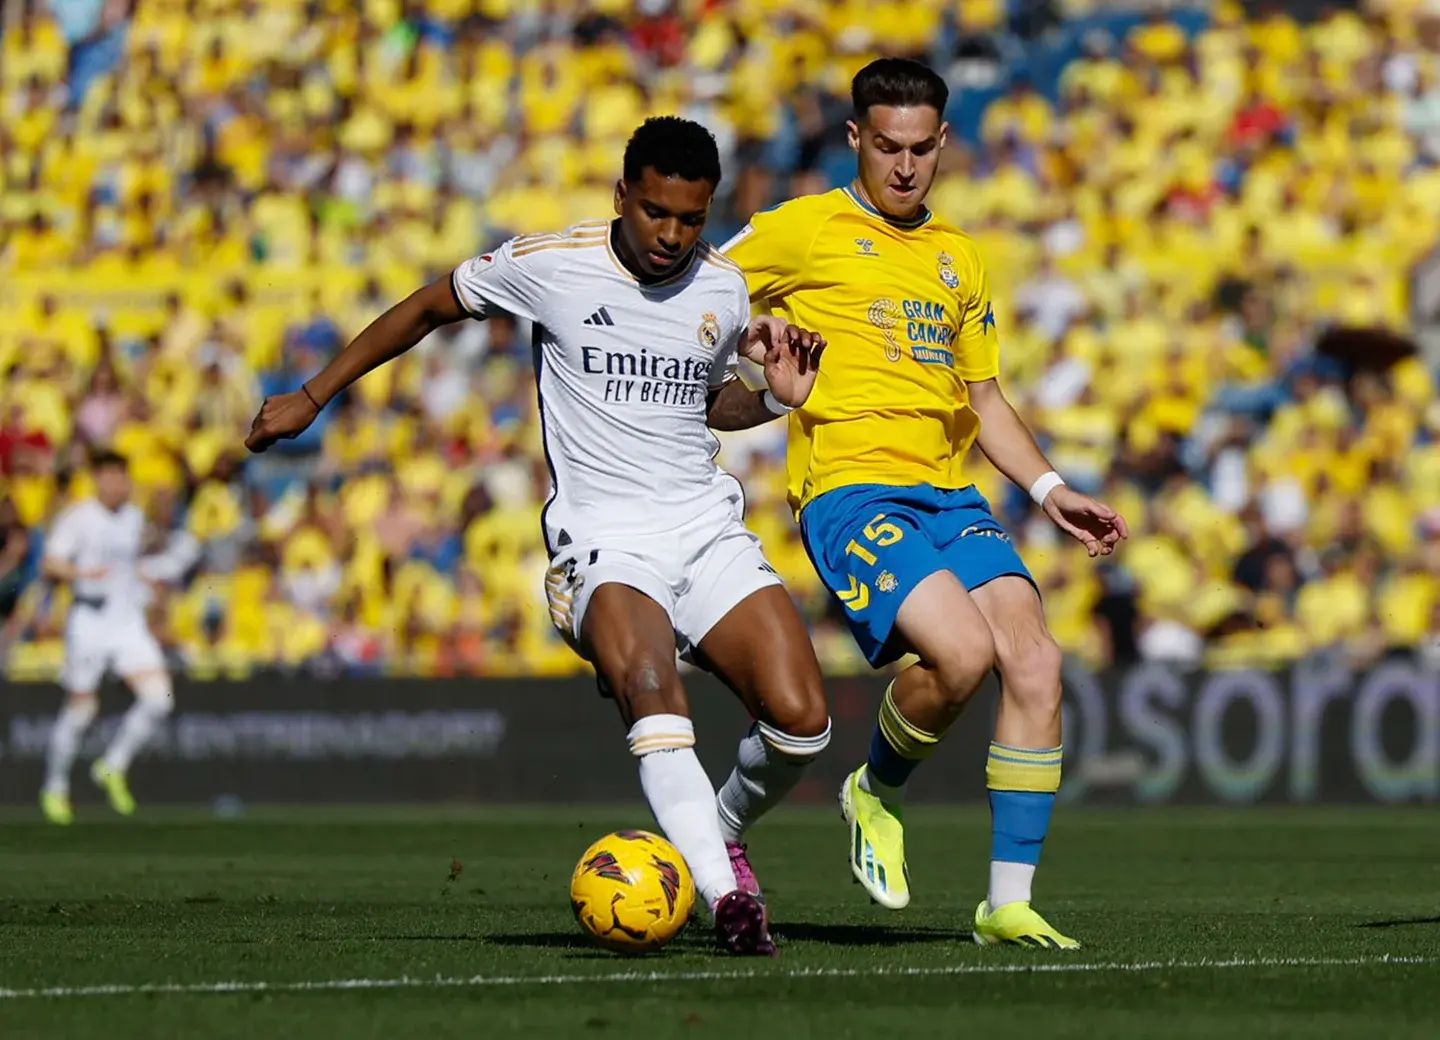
[969,379,1130,556]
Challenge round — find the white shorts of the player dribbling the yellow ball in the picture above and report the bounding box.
[544,504,782,655]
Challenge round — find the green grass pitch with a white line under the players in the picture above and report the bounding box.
[0,808,1440,1040]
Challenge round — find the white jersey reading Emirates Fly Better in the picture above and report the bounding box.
[452,220,750,553]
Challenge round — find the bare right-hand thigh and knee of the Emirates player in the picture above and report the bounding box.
[694,585,829,736]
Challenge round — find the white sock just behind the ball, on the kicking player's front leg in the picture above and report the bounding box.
[626,714,737,907]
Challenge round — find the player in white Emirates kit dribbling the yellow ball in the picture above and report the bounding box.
[246,117,829,955]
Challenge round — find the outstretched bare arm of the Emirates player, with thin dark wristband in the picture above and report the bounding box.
[245,277,469,451]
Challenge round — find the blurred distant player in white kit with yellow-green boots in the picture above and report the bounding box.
[40,452,199,824]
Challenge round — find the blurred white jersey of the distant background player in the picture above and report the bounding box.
[45,498,199,615]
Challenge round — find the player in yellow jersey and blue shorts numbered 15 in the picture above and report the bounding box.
[724,58,1128,949]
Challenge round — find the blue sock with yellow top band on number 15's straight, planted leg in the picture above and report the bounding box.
[985,743,1063,910]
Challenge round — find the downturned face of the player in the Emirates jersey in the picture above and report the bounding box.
[615,166,716,278]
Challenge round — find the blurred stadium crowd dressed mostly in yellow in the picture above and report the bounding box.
[0,0,1440,677]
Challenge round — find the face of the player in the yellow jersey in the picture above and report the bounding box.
[848,105,950,218]
